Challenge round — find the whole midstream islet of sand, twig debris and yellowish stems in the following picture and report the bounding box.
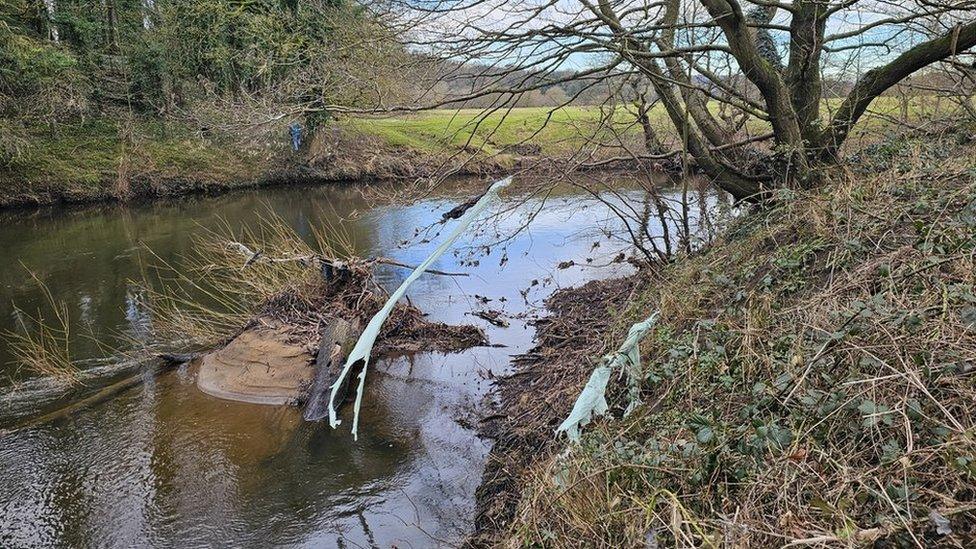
[138,209,485,412]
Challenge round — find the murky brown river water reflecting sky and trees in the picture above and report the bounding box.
[0,178,716,547]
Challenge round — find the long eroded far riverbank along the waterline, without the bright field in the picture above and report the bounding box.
[0,120,680,211]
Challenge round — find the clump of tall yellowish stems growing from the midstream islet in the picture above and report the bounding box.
[142,210,354,348]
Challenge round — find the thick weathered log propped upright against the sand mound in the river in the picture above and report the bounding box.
[303,318,359,421]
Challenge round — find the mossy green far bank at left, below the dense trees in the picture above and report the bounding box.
[0,118,290,206]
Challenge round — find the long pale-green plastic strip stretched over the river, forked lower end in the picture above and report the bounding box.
[329,177,512,439]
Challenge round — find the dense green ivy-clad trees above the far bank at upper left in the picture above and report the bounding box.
[0,0,410,161]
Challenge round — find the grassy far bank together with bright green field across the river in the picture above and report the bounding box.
[0,97,960,207]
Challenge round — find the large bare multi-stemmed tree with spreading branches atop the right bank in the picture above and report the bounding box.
[387,0,976,199]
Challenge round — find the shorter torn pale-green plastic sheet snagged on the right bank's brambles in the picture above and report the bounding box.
[556,312,658,442]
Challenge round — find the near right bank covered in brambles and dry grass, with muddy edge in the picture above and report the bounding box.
[471,127,976,547]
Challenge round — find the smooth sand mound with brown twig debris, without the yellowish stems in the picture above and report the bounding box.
[196,261,487,406]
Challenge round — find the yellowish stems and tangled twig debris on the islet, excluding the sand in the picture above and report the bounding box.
[140,210,485,354]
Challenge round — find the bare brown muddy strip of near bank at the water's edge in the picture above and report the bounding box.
[468,271,652,547]
